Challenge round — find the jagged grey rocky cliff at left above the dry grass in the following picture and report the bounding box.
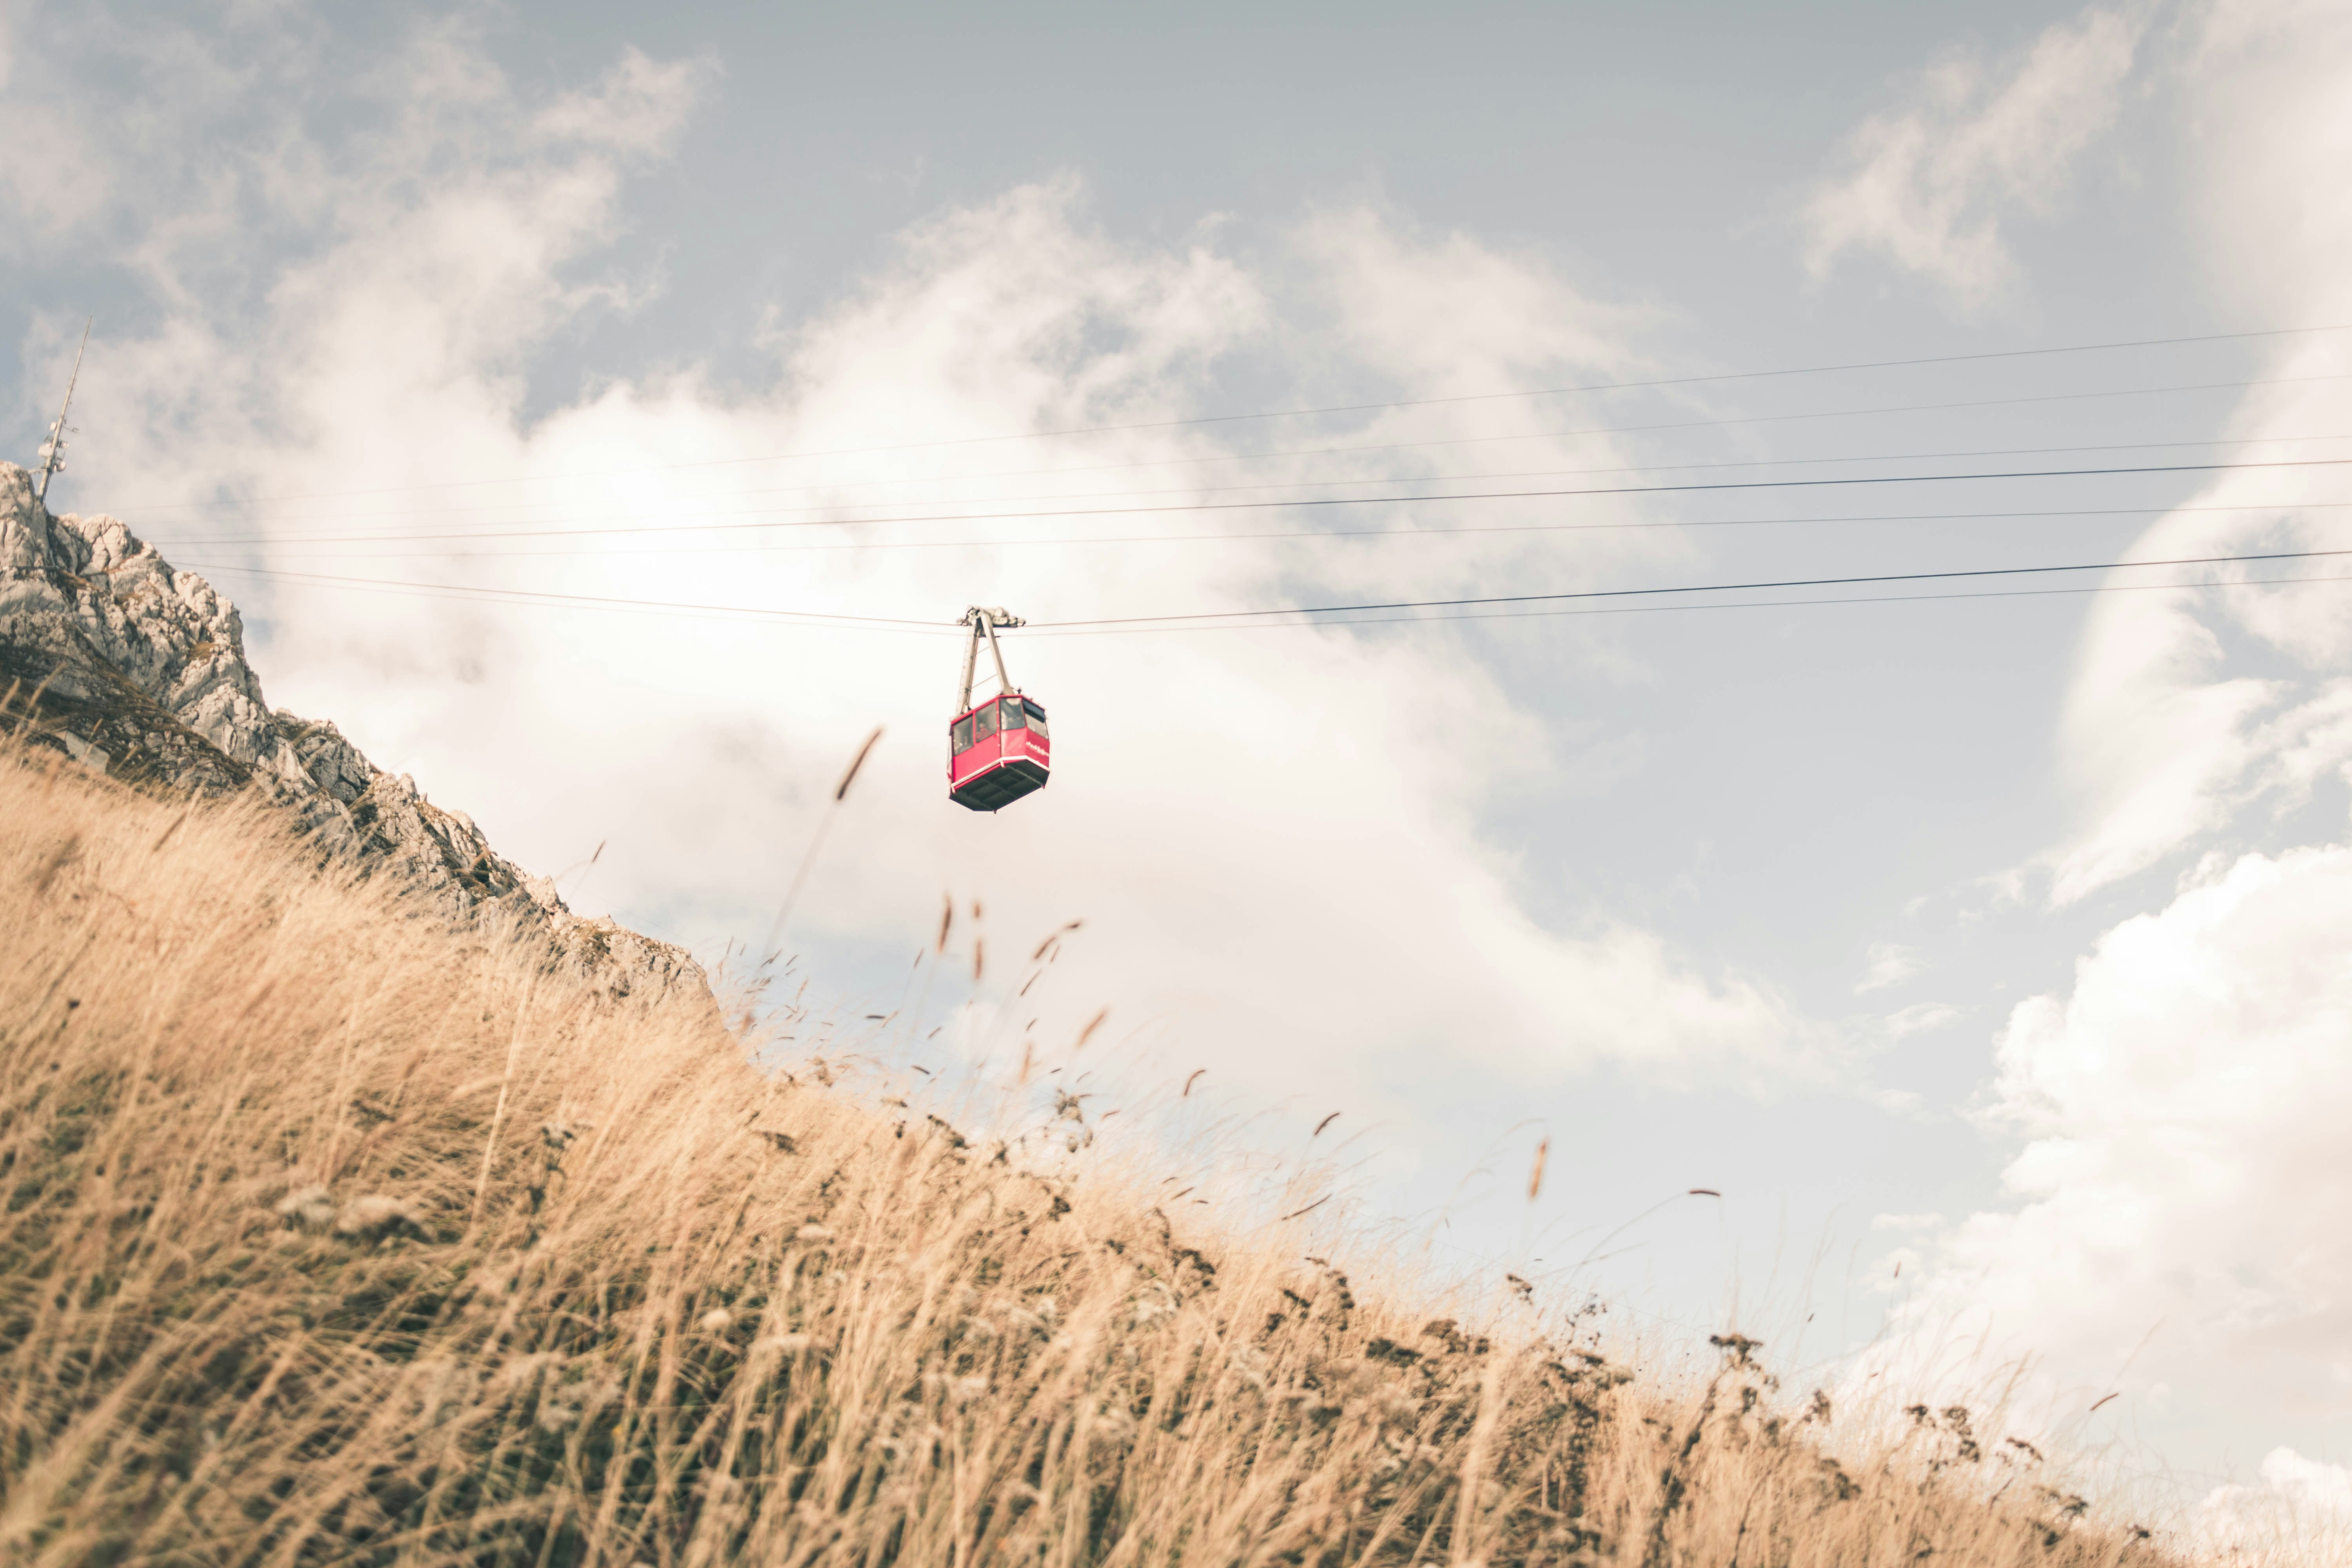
[0,463,708,995]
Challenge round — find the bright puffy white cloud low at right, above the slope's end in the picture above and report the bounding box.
[1896,846,2352,1448]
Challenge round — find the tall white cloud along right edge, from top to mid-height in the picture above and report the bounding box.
[2039,5,2352,903]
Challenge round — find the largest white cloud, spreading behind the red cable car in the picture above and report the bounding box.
[4,12,1830,1128]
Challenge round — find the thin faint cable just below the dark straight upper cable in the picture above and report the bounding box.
[202,501,2352,562]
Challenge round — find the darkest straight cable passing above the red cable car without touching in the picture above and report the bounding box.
[156,458,2352,545]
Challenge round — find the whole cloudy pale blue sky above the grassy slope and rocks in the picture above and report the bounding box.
[0,0,2352,1542]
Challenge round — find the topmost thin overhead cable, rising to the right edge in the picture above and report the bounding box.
[73,325,2352,503]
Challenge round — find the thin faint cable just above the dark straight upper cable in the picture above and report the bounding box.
[139,416,2352,543]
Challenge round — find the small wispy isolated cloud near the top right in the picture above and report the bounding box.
[1804,9,2140,301]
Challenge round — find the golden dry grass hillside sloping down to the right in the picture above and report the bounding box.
[0,750,2161,1568]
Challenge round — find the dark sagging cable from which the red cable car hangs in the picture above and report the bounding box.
[171,548,2352,632]
